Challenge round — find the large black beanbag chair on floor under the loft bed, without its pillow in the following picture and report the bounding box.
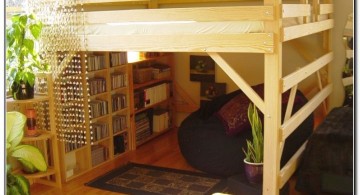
[178,85,313,177]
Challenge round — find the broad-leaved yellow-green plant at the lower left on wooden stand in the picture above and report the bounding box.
[6,111,47,195]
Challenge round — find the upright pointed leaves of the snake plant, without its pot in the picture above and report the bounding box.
[242,103,264,163]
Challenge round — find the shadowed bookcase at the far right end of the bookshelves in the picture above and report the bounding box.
[129,52,175,149]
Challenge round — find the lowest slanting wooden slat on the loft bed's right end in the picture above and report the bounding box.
[279,141,307,188]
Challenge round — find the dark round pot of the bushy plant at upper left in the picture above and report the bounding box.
[11,81,34,100]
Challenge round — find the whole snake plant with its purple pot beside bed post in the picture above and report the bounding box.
[243,103,264,183]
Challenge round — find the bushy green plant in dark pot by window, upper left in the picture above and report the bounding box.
[6,13,48,99]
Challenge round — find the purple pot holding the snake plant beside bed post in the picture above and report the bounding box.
[244,159,263,184]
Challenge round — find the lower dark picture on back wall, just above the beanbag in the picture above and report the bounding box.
[200,82,226,100]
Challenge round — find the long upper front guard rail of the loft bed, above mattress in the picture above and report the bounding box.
[84,6,274,24]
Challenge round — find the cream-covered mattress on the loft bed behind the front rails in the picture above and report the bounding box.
[78,18,300,35]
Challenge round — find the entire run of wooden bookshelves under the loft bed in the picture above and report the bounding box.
[59,51,174,182]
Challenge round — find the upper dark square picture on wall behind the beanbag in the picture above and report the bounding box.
[190,55,215,82]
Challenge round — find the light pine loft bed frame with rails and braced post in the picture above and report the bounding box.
[78,0,334,194]
